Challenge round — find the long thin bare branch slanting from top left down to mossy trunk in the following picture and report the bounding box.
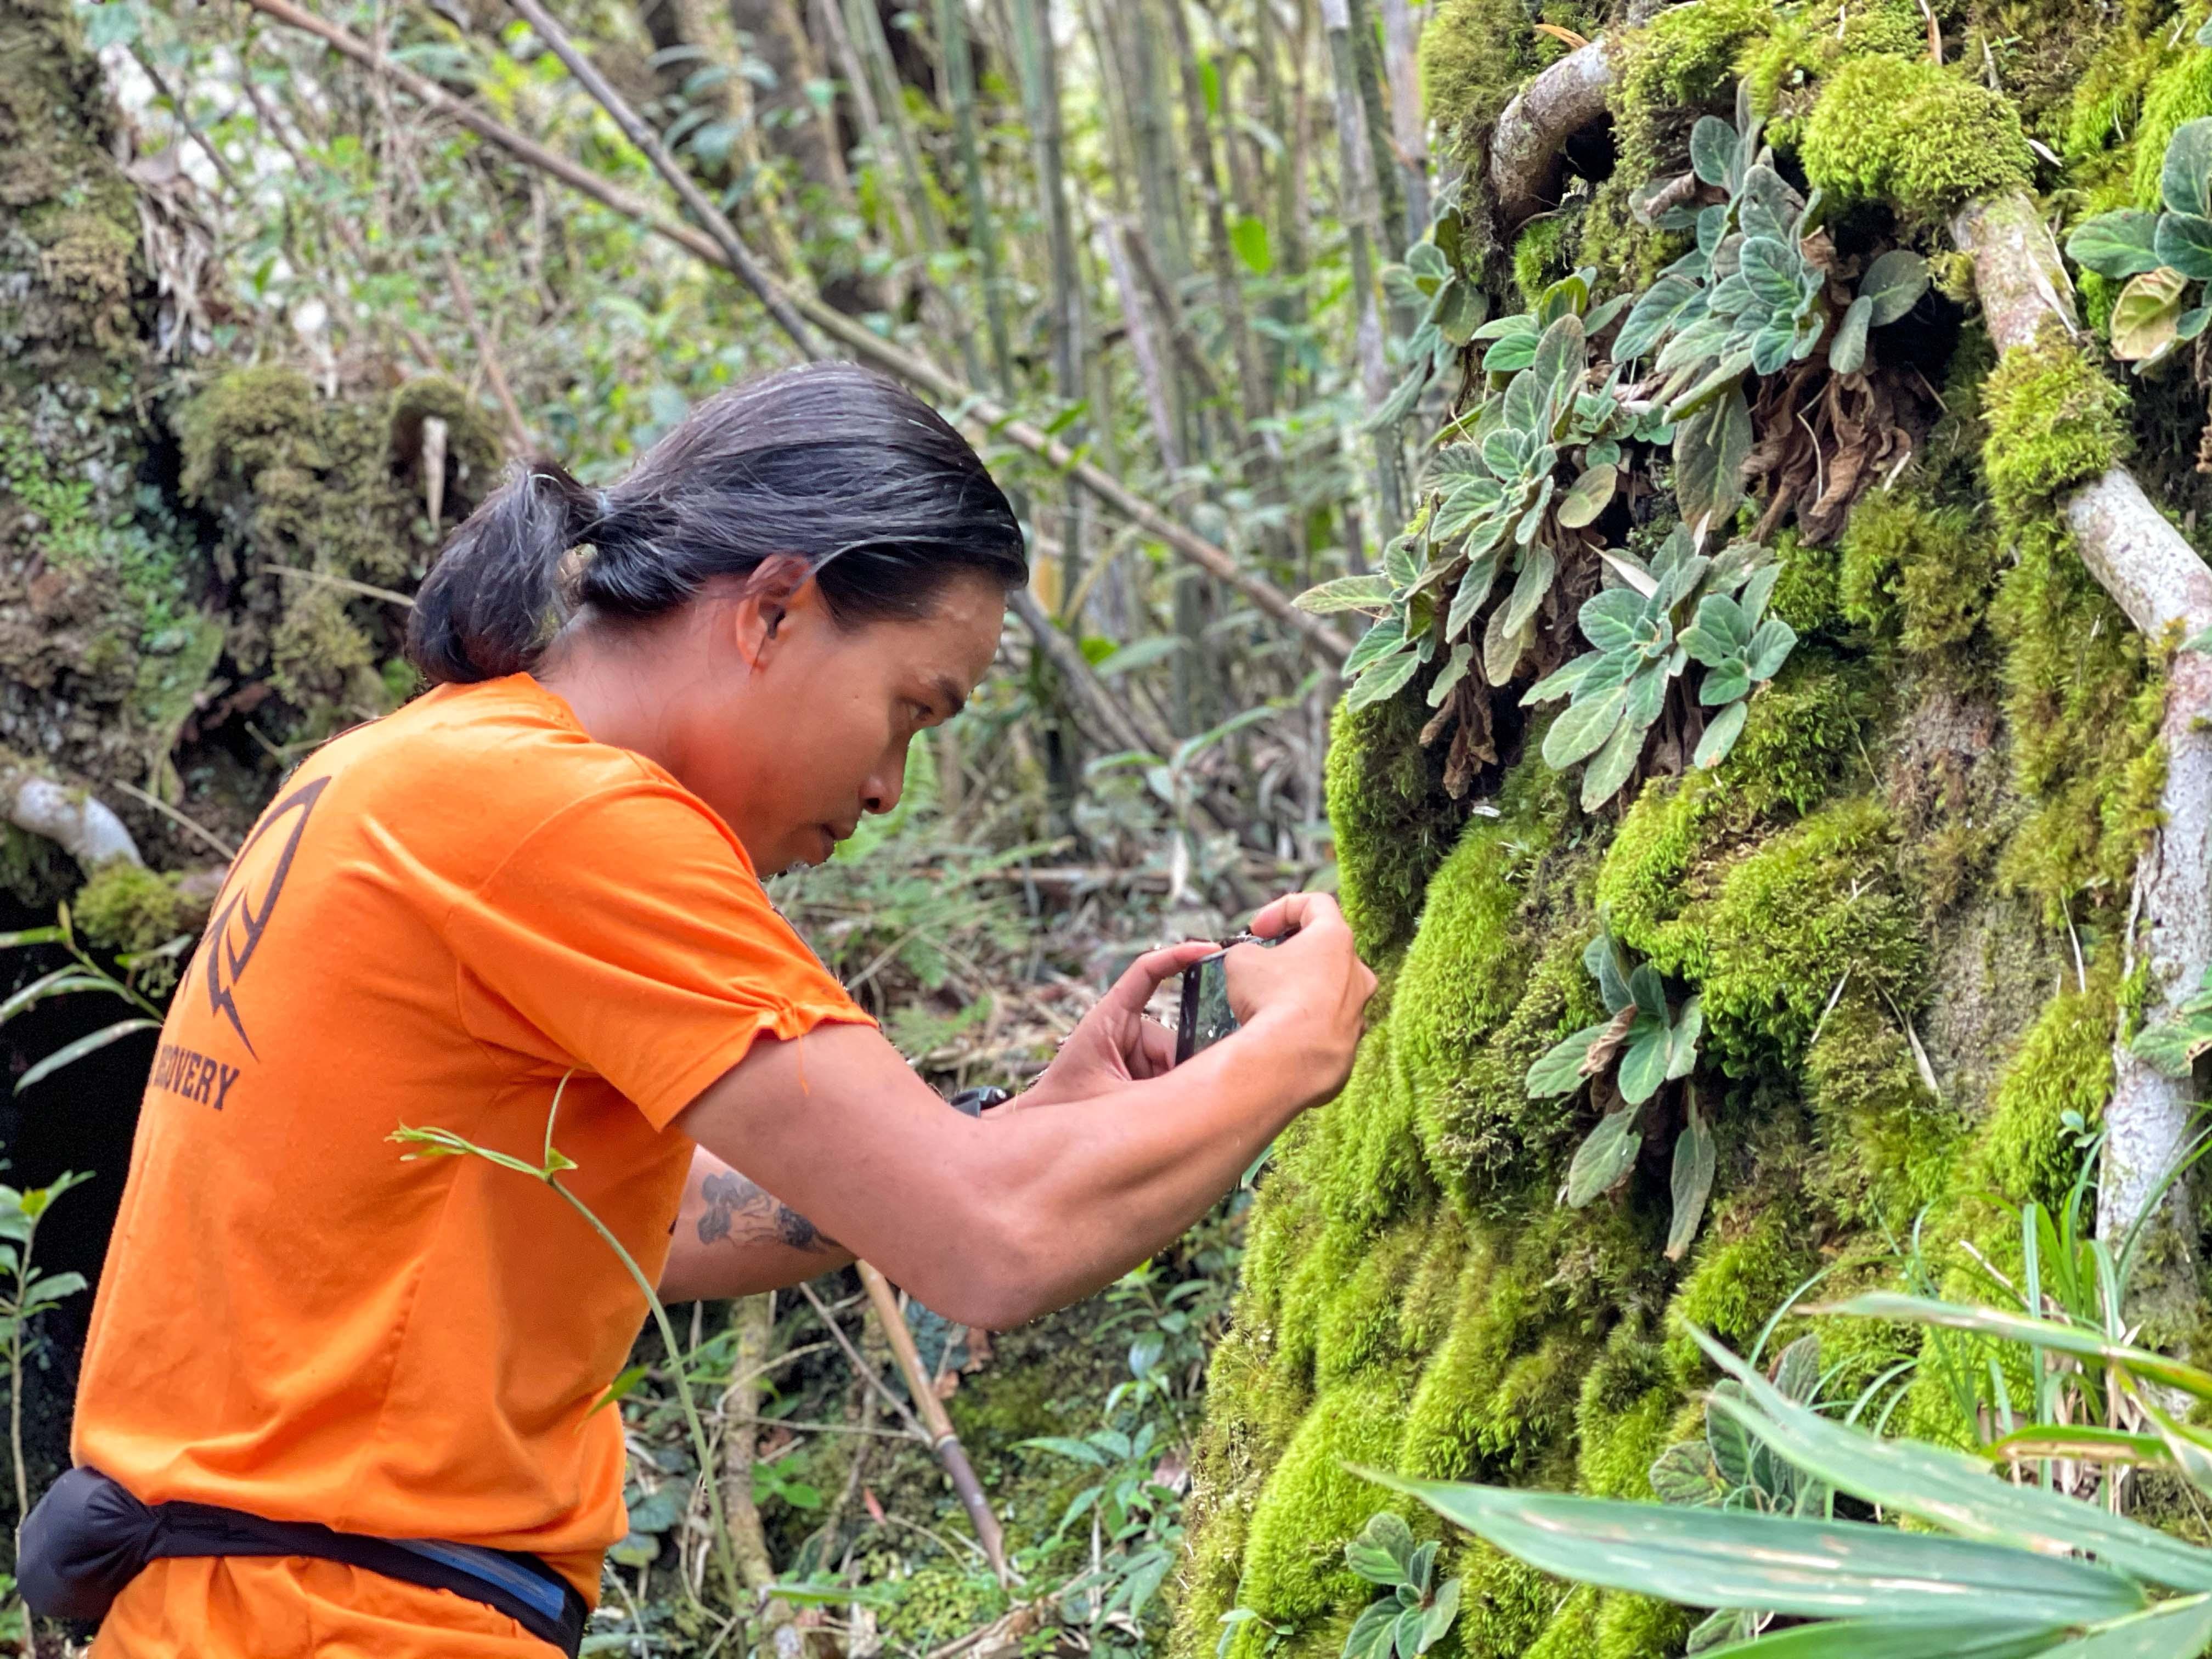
[250,0,1352,662]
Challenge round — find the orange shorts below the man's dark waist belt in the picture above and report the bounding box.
[93,1555,553,1659]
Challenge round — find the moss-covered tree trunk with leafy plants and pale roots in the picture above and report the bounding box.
[1177,0,2212,1659]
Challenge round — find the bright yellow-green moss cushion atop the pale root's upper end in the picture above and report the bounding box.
[1798,58,2033,217]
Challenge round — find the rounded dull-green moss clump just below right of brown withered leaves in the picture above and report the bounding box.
[1841,491,2000,657]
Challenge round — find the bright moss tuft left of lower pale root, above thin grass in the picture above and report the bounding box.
[1973,969,2119,1210]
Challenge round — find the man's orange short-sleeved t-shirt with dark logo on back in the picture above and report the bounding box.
[75,675,867,1601]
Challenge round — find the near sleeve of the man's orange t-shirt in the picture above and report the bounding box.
[447,778,870,1128]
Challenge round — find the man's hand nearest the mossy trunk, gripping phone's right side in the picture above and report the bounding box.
[1226,894,1376,1106]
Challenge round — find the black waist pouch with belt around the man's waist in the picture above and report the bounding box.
[15,1469,586,1659]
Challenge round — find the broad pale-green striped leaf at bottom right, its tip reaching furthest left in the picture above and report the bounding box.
[1354,1469,2143,1628]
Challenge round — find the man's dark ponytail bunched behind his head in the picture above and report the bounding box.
[407,460,600,686]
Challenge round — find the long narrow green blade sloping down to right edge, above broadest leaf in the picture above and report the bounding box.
[1690,1329,2212,1590]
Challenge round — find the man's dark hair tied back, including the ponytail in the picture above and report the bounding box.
[407,363,1029,684]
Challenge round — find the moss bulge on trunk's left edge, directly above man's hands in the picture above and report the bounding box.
[1327,697,1464,962]
